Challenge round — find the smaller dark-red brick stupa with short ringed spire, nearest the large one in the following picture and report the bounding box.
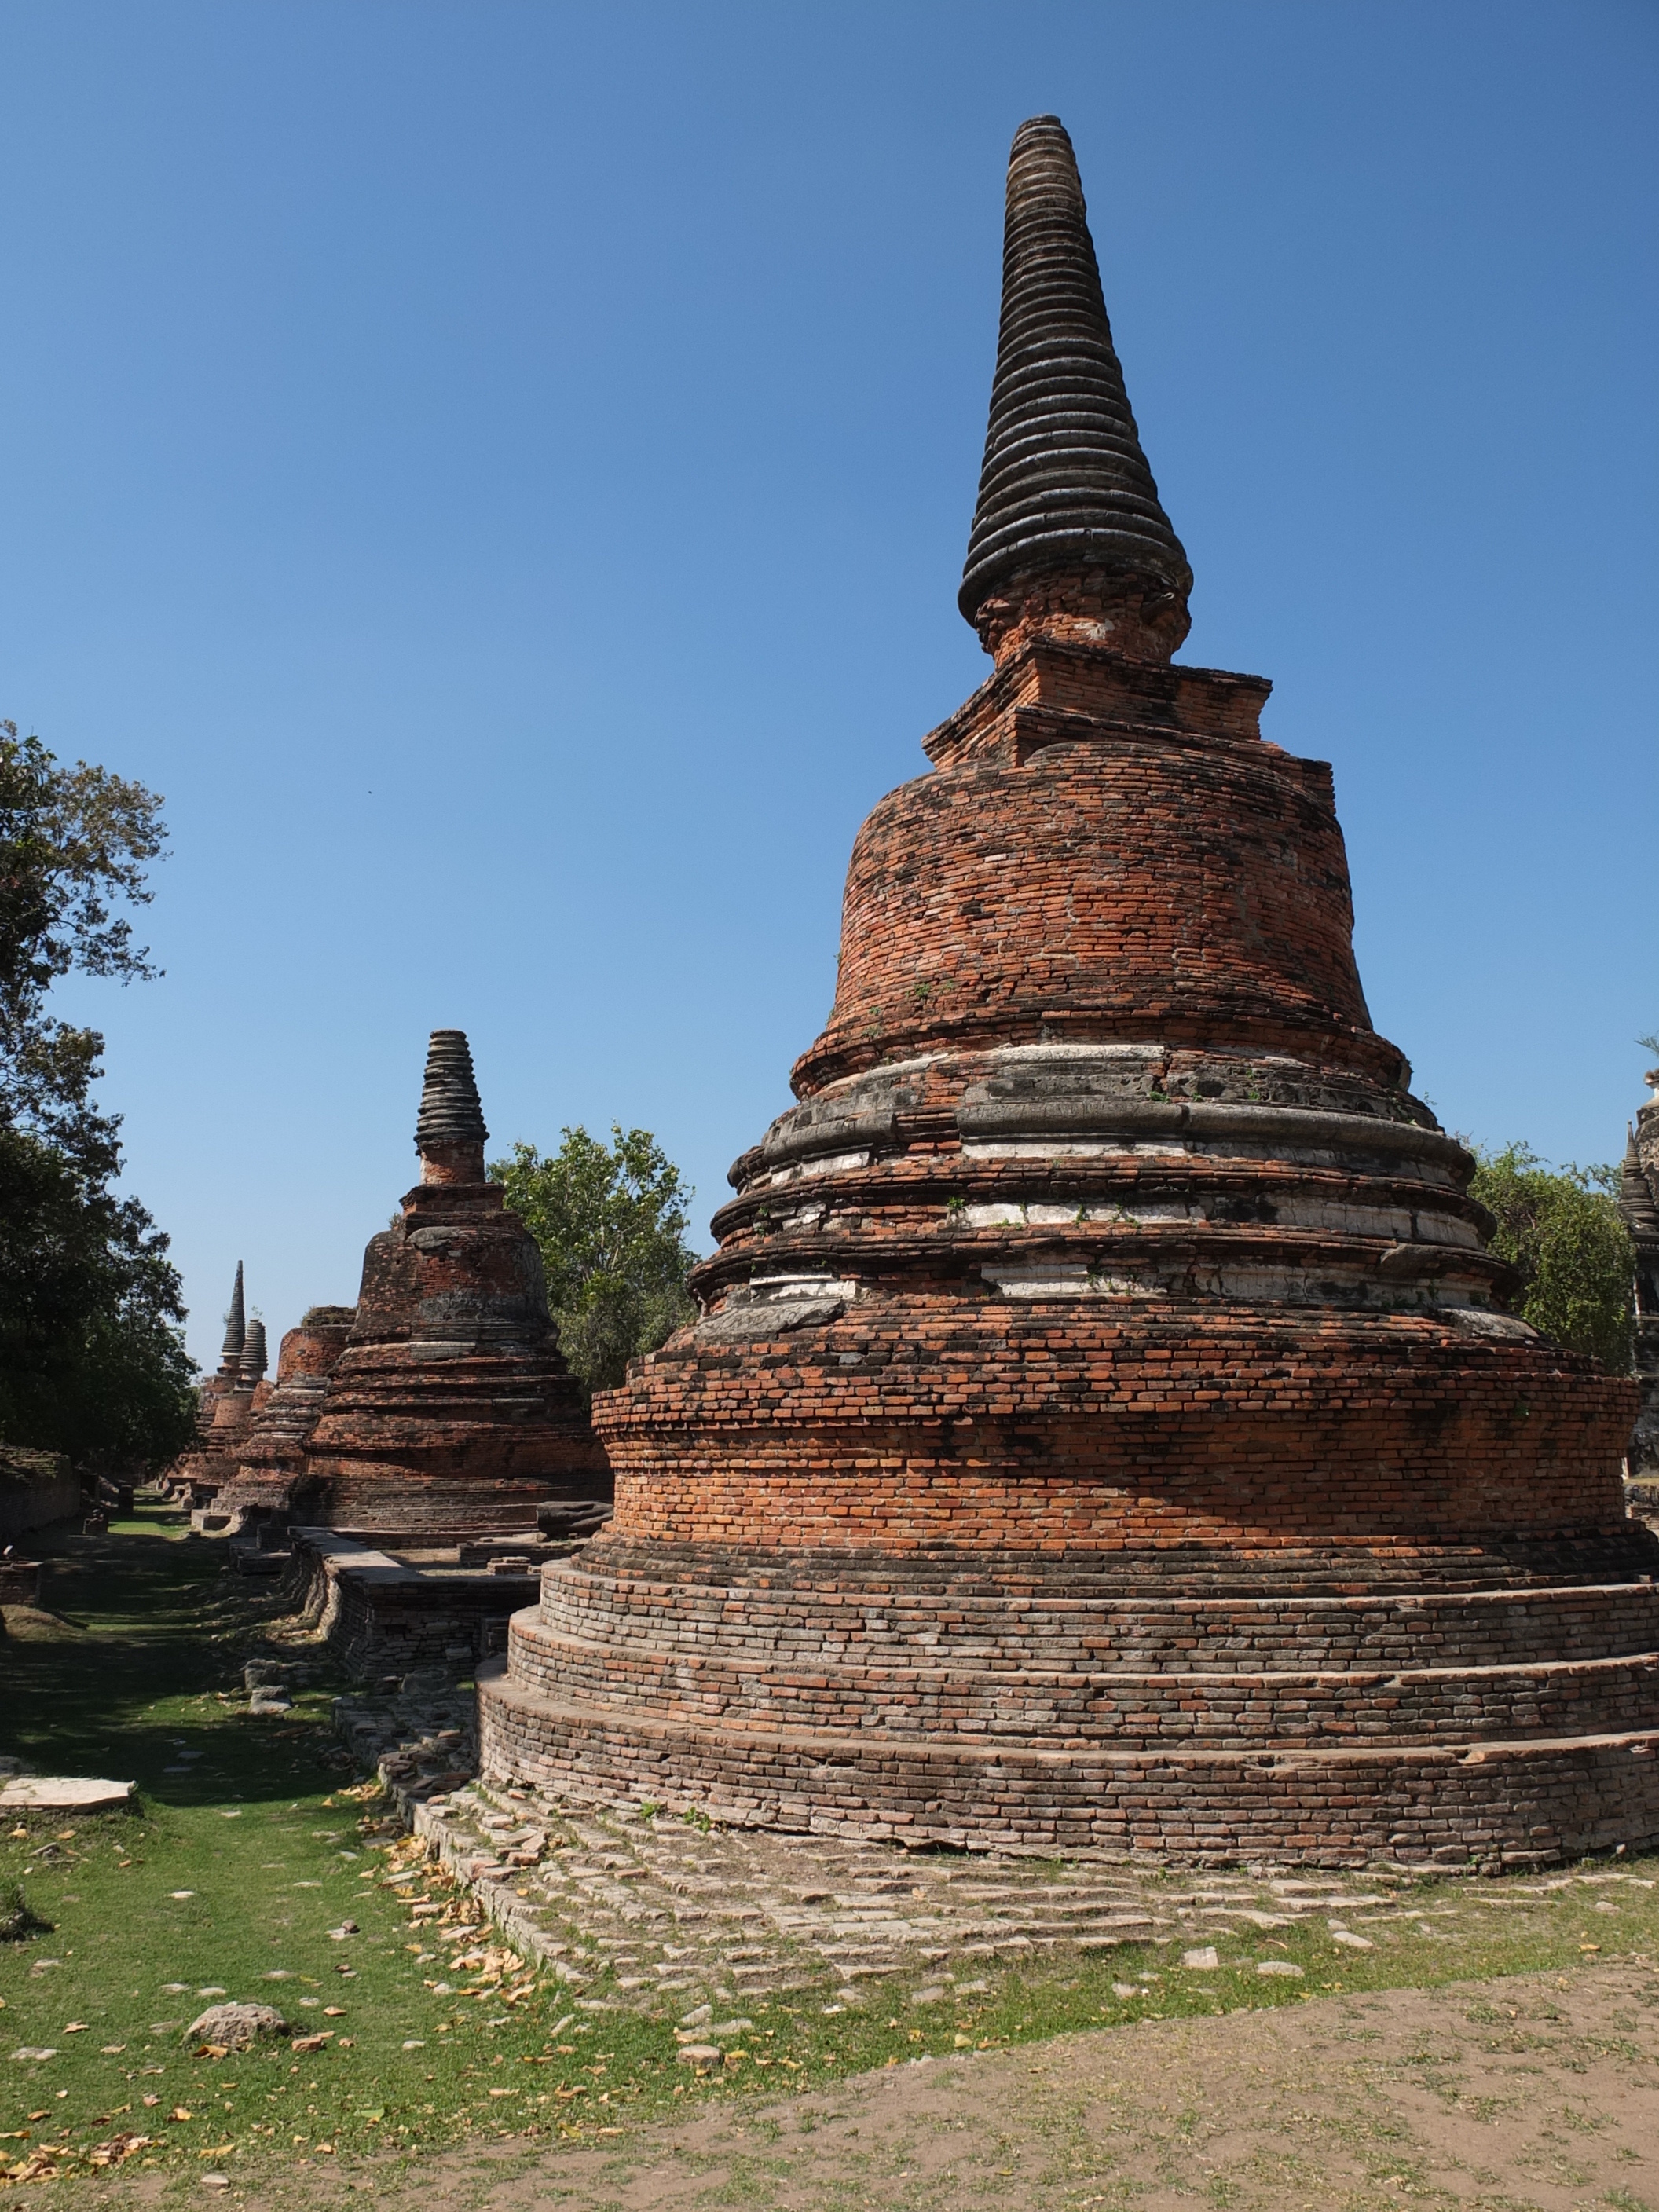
[295,1028,610,1542]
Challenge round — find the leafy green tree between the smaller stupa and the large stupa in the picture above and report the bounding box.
[489,1122,697,1391]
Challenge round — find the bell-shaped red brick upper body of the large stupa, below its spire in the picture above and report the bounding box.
[797,648,1401,1095]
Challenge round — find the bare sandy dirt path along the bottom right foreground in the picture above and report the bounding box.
[191,1966,1659,2212]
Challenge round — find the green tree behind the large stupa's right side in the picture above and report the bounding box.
[1469,1144,1637,1374]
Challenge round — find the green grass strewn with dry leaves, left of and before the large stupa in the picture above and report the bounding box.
[0,1509,1659,2194]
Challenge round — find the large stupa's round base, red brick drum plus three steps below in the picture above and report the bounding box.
[480,1307,1659,1865]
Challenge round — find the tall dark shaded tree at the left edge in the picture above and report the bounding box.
[0,721,192,1467]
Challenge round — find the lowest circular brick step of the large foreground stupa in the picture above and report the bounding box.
[480,1670,1659,1867]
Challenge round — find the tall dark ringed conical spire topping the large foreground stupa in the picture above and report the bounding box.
[958,115,1192,642]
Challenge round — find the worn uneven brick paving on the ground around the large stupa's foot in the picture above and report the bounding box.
[336,1681,1592,2033]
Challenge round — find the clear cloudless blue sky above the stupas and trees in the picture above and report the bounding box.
[0,0,1659,1358]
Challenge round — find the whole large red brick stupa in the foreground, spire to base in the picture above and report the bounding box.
[480,117,1659,1865]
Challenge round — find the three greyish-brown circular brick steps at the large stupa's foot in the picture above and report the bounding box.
[480,1548,1659,1865]
